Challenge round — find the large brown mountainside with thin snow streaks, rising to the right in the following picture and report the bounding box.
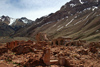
[15,0,100,41]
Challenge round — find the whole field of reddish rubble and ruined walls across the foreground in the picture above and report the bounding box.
[0,33,100,67]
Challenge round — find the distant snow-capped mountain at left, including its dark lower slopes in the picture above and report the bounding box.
[0,15,34,37]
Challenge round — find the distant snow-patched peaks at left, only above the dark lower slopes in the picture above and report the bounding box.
[0,15,34,30]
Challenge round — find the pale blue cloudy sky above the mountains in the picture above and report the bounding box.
[0,0,70,20]
